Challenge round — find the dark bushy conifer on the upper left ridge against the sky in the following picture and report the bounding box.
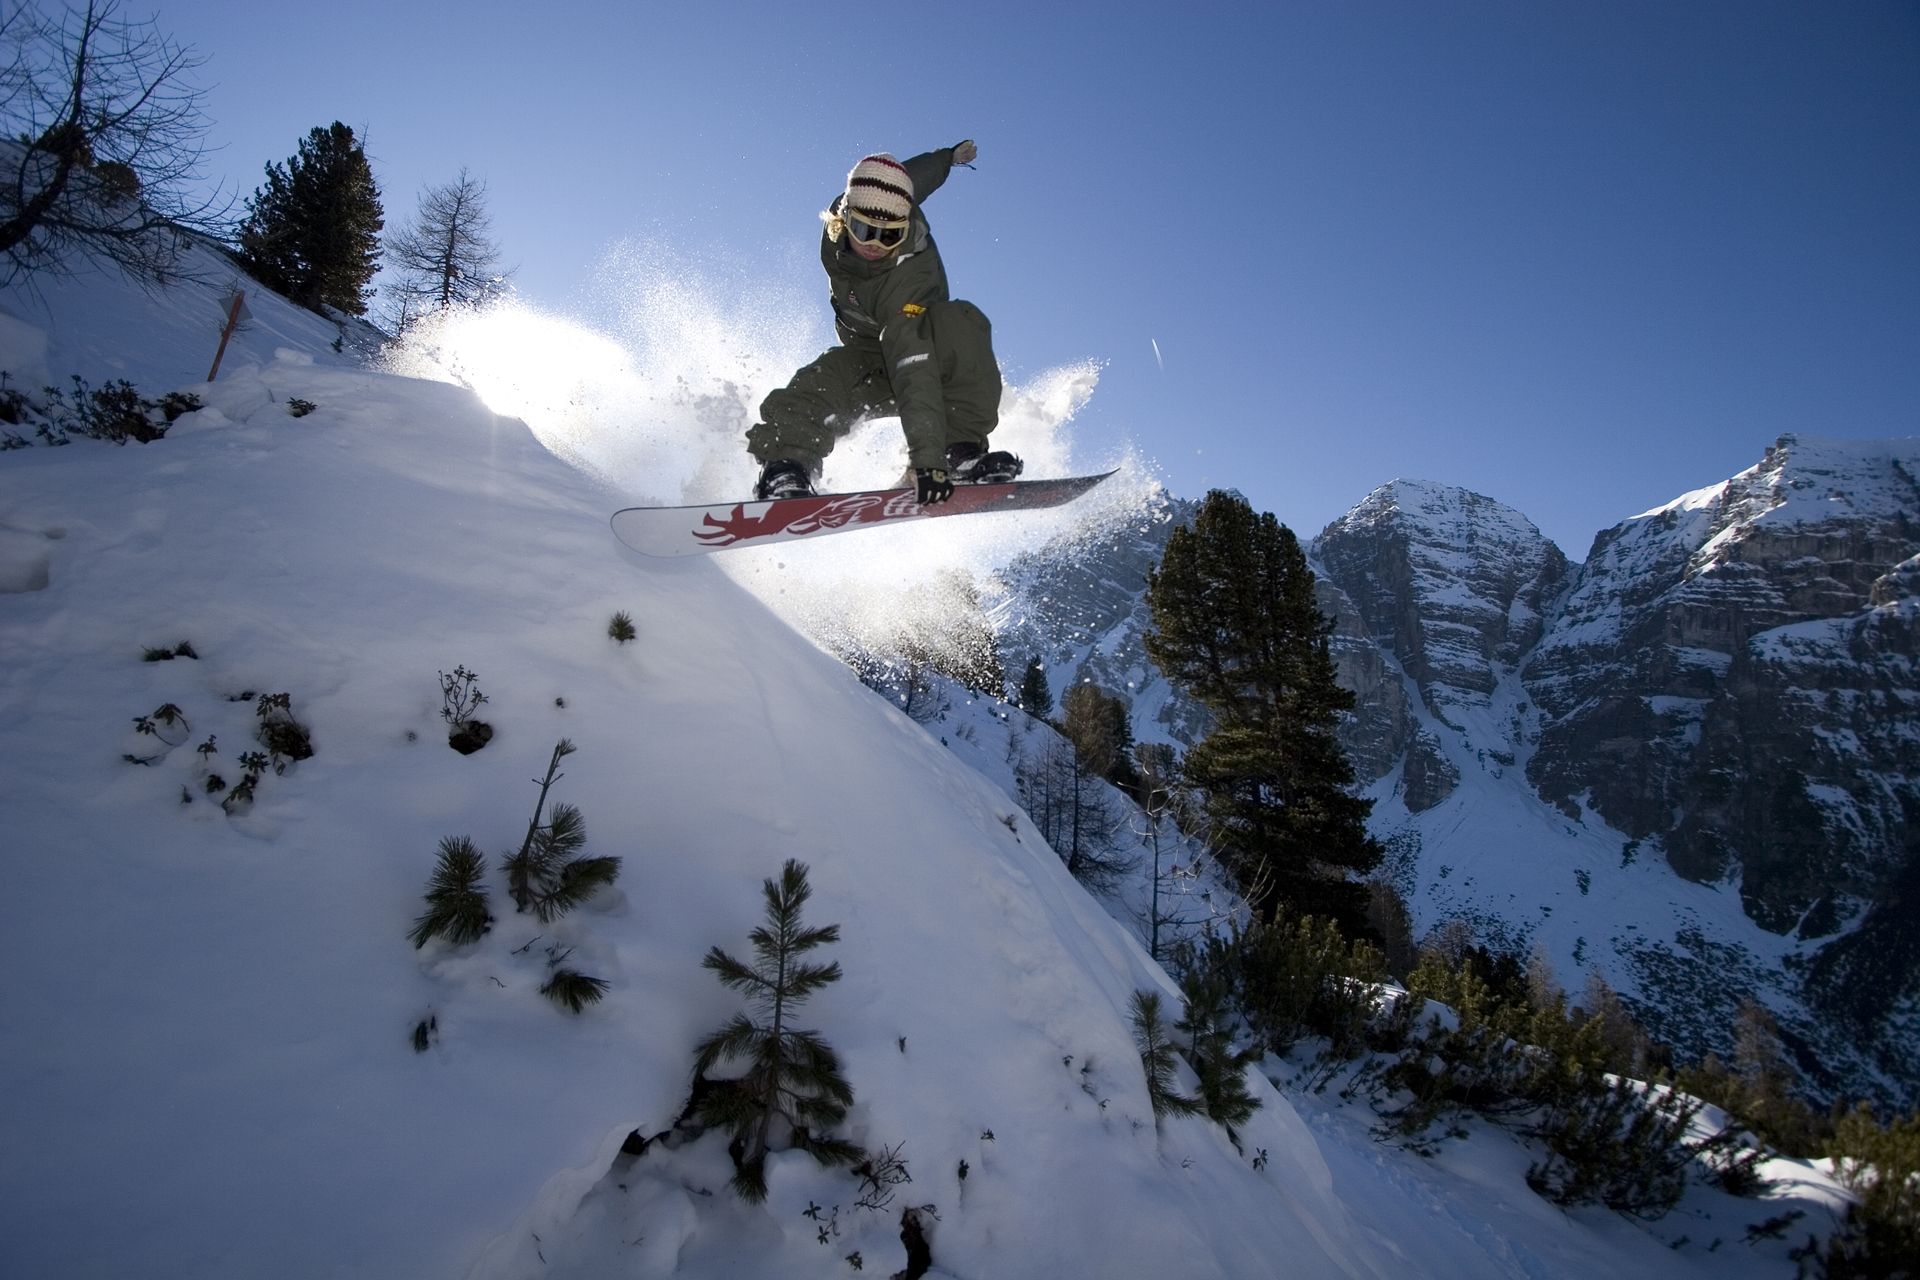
[240,121,386,315]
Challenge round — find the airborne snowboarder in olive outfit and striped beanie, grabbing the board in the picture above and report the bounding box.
[747,140,1021,507]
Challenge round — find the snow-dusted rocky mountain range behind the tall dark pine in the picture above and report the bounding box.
[1014,449,1920,1105]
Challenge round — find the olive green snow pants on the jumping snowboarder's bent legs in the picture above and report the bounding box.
[747,301,1000,474]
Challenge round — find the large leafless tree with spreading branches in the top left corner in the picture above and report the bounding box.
[0,0,232,284]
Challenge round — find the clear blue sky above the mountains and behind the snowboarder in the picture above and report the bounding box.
[157,0,1920,558]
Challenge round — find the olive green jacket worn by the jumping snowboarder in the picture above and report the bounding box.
[820,148,975,466]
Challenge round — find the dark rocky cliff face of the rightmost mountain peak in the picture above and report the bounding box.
[1526,436,1920,936]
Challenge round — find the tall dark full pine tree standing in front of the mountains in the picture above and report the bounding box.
[1146,489,1382,929]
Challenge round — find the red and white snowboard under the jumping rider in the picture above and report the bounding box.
[612,472,1114,557]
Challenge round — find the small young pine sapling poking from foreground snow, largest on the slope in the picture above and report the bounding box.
[693,858,862,1203]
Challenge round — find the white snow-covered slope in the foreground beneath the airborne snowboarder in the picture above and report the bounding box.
[0,245,1858,1278]
